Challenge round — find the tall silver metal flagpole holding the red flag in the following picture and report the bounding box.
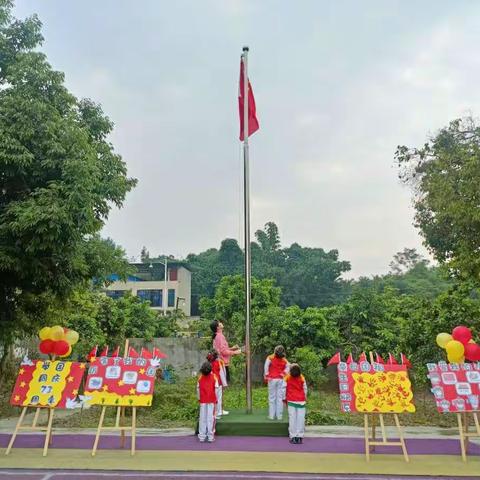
[242,46,252,413]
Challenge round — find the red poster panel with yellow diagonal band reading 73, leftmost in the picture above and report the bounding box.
[10,359,85,408]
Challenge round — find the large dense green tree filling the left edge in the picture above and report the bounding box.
[0,0,135,360]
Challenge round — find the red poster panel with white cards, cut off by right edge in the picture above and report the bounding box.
[427,362,480,413]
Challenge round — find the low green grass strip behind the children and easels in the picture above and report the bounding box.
[37,380,456,428]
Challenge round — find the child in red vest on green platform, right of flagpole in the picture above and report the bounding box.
[263,345,289,420]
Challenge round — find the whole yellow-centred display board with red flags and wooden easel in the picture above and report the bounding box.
[329,353,415,462]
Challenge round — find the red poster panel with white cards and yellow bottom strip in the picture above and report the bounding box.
[85,357,159,407]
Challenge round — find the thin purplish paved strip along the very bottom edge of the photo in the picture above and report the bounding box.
[0,470,472,480]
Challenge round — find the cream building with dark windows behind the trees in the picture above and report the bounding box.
[105,259,192,317]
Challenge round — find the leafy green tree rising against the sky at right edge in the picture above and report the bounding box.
[396,118,480,282]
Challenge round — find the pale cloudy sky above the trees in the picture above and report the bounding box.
[15,0,480,277]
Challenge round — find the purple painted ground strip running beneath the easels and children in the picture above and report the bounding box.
[0,434,480,455]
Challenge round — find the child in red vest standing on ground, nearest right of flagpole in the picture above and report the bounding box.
[282,363,307,443]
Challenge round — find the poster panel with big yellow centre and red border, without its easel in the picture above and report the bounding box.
[337,362,415,413]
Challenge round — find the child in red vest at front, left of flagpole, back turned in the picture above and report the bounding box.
[197,362,218,442]
